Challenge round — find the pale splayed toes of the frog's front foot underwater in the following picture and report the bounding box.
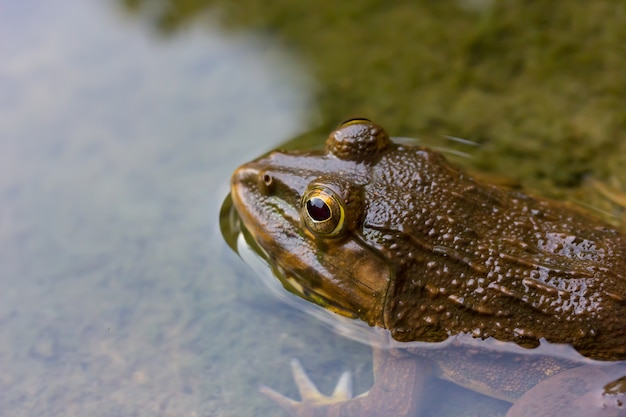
[261,359,352,414]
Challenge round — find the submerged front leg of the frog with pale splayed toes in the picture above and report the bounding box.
[261,349,431,417]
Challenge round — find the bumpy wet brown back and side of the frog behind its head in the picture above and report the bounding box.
[368,141,626,360]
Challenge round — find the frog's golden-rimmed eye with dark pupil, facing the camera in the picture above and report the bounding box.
[301,187,346,237]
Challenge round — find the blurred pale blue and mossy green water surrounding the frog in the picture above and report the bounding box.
[0,0,626,416]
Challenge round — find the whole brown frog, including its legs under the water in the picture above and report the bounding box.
[230,118,626,417]
